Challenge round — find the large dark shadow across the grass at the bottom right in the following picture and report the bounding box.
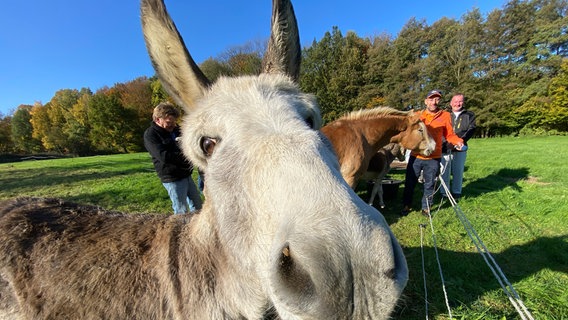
[393,235,568,319]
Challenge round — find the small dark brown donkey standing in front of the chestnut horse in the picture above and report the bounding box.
[362,143,405,209]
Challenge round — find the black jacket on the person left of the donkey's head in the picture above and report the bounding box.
[144,122,193,182]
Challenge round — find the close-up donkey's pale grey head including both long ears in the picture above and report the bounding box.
[142,0,408,319]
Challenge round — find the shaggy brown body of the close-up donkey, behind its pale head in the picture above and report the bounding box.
[0,198,204,319]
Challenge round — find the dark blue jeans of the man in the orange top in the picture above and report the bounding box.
[402,156,441,210]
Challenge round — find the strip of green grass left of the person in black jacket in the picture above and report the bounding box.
[0,153,202,213]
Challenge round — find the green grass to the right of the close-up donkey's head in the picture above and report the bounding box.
[374,137,568,319]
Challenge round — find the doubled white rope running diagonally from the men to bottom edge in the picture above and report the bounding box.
[438,175,534,320]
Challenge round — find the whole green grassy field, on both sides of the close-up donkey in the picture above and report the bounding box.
[0,137,568,319]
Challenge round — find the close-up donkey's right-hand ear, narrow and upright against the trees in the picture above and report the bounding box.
[262,0,301,82]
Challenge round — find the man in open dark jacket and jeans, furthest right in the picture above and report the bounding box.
[440,93,475,200]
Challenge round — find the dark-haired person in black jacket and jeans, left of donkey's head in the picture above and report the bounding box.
[144,103,202,214]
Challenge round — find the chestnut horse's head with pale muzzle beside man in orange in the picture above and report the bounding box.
[398,111,436,156]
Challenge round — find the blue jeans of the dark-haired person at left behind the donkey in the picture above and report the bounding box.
[162,176,202,214]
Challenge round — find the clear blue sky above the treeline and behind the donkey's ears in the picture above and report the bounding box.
[0,0,506,116]
